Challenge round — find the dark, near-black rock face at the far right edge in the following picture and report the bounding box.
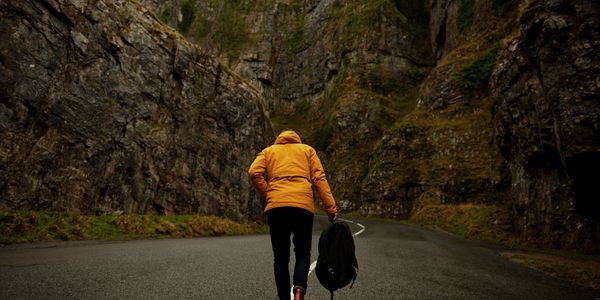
[493,0,600,249]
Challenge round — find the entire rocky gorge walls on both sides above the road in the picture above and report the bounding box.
[0,0,600,252]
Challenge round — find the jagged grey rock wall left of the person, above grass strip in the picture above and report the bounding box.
[0,0,273,219]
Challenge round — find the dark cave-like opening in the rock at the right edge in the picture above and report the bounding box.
[567,152,600,221]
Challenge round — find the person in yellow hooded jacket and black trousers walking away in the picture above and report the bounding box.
[248,130,337,299]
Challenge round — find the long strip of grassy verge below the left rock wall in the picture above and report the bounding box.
[0,211,267,244]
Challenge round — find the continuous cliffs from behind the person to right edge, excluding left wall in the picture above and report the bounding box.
[153,0,599,248]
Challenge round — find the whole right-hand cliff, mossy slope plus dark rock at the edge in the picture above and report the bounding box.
[361,0,600,252]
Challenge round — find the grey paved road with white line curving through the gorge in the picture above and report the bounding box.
[0,218,600,300]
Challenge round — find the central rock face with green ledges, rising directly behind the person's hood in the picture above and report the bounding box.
[144,0,433,209]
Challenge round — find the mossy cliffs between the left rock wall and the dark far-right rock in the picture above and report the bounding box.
[148,0,515,218]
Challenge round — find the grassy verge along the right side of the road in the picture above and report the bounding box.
[410,204,600,290]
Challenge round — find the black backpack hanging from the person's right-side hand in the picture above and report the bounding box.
[315,221,358,299]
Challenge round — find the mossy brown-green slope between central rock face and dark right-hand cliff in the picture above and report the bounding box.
[360,0,514,218]
